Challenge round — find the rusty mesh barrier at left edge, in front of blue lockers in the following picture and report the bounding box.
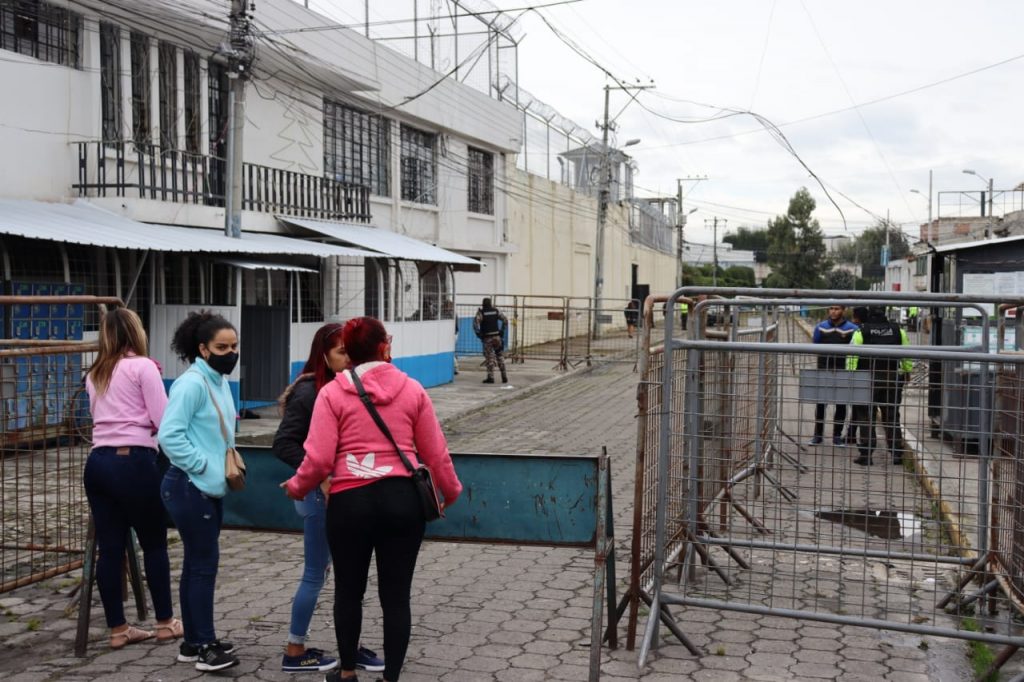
[0,296,121,593]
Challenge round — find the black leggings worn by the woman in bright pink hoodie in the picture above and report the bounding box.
[327,477,426,682]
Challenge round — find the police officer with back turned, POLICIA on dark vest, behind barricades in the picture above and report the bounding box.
[846,307,913,466]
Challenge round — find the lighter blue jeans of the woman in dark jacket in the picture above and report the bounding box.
[288,485,331,644]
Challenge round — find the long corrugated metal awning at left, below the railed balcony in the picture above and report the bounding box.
[0,199,378,258]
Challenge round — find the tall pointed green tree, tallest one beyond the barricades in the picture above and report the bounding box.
[765,187,831,289]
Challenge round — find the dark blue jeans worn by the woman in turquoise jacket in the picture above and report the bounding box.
[160,466,224,645]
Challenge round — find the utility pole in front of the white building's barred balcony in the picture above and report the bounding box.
[220,0,253,239]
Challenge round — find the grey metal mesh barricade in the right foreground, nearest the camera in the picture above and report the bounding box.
[631,289,1024,665]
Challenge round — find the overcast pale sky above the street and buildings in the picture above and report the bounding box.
[313,0,1024,242]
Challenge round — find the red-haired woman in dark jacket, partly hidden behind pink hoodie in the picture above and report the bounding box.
[273,323,384,673]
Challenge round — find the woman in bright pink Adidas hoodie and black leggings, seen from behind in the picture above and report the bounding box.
[285,317,462,682]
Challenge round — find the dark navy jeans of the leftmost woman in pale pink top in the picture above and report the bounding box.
[83,446,174,628]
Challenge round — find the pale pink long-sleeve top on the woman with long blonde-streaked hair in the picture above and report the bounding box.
[85,355,167,450]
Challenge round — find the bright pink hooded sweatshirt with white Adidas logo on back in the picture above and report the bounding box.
[288,361,462,505]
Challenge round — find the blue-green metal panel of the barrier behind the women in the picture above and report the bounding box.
[224,446,599,547]
